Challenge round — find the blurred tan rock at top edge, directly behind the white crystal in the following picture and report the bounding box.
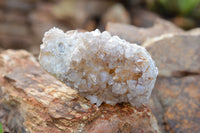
[51,0,113,29]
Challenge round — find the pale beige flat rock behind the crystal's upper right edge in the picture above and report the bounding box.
[106,18,183,44]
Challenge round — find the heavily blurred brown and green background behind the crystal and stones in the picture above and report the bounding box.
[0,0,200,56]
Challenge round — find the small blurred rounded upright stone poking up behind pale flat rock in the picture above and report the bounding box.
[102,3,131,25]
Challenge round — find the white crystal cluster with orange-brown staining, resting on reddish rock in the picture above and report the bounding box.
[39,28,158,106]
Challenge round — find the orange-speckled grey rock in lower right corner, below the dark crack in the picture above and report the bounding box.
[150,75,200,133]
